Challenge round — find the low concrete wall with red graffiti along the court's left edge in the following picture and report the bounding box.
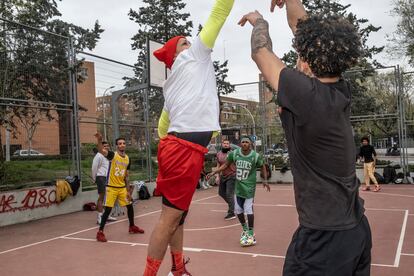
[0,186,97,227]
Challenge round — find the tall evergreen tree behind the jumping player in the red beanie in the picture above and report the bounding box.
[126,0,234,125]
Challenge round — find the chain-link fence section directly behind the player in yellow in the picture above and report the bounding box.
[77,52,156,189]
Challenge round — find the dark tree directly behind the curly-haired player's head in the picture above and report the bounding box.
[282,0,384,115]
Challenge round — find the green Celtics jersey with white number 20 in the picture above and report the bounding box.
[227,149,263,198]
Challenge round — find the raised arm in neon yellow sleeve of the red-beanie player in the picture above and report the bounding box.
[200,0,234,49]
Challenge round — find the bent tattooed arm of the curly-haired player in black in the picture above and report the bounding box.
[239,11,286,90]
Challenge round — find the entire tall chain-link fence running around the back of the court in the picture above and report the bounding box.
[4,16,414,190]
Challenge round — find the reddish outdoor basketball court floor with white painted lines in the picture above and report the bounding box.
[0,185,414,276]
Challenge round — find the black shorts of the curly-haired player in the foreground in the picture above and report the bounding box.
[283,216,372,276]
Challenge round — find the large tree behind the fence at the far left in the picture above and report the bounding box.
[0,0,103,182]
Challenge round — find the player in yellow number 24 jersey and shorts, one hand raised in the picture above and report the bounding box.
[95,133,144,242]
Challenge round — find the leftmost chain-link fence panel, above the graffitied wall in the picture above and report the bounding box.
[0,19,79,190]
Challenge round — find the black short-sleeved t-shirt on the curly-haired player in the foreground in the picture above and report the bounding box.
[278,68,364,230]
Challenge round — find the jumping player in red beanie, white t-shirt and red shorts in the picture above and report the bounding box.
[144,0,234,276]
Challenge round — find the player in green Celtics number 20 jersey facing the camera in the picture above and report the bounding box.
[207,136,270,246]
